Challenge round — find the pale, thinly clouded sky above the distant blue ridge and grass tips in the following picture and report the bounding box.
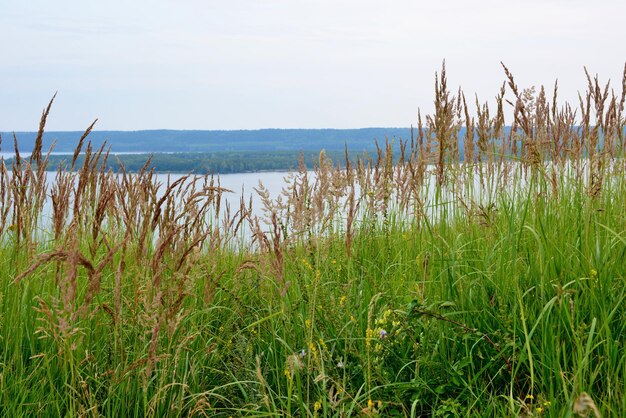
[0,0,626,131]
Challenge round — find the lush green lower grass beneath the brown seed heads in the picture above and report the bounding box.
[0,163,626,417]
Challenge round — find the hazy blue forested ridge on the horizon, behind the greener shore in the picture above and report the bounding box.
[6,128,411,153]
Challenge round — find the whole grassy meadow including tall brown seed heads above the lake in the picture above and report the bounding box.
[0,62,626,417]
